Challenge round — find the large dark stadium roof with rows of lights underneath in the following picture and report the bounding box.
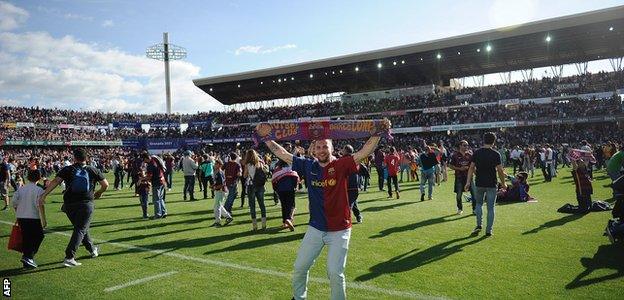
[193,6,624,105]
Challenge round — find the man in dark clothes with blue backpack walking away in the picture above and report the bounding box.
[39,148,108,267]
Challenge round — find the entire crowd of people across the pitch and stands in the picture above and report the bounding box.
[0,72,624,298]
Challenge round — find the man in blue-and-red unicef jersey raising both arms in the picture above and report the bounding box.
[266,119,390,299]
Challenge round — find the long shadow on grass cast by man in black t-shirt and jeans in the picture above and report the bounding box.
[355,236,486,281]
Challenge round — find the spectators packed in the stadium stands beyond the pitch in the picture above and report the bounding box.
[0,72,624,141]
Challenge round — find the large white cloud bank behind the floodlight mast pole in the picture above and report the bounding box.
[0,32,222,113]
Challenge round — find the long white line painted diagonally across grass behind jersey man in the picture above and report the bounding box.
[0,220,448,300]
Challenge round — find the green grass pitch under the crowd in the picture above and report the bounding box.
[0,169,624,299]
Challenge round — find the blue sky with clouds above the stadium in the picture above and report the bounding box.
[0,0,624,113]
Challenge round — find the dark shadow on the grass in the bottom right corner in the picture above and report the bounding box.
[566,244,624,290]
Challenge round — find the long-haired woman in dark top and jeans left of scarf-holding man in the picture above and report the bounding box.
[243,149,268,231]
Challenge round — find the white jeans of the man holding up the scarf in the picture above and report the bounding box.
[293,226,351,300]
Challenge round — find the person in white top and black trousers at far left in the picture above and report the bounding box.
[13,170,47,269]
